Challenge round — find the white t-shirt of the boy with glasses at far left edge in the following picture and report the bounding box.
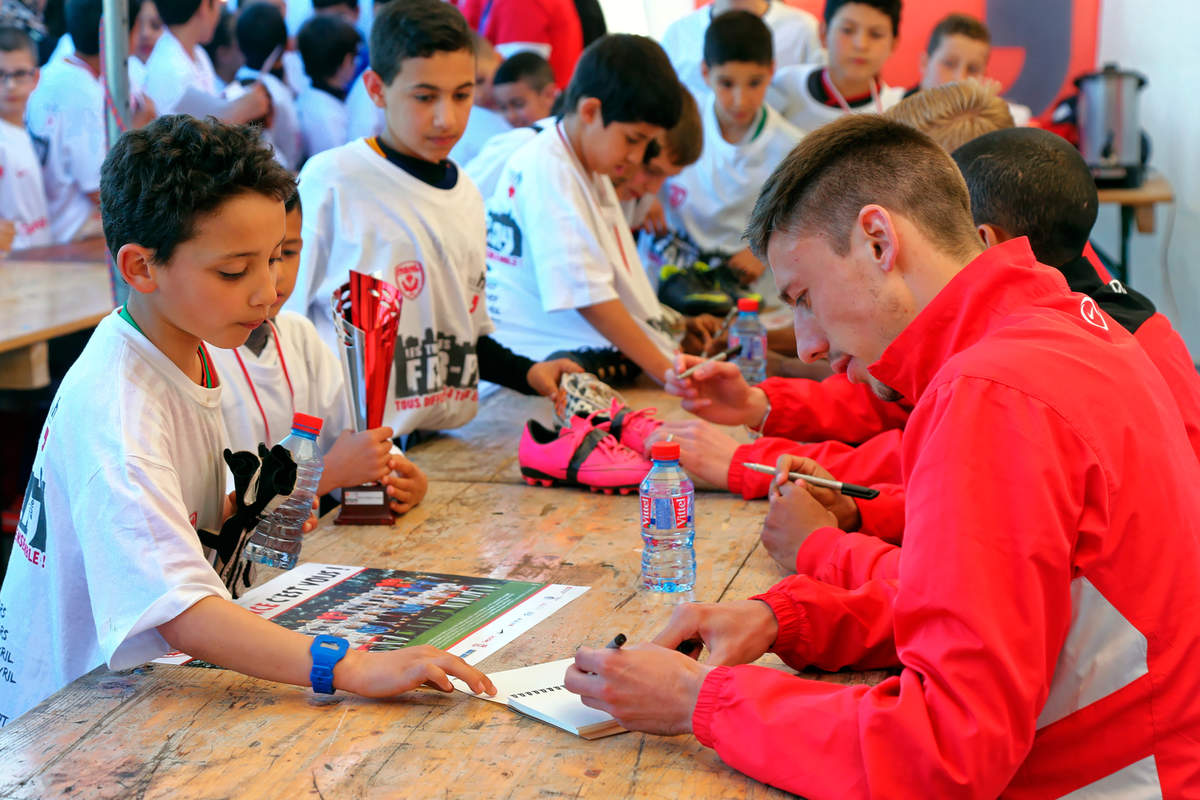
[0,120,54,249]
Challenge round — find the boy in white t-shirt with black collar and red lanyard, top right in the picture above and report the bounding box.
[767,0,904,133]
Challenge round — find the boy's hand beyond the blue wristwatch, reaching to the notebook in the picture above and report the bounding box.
[334,644,496,697]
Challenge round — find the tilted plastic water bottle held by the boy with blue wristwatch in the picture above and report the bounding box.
[242,414,325,570]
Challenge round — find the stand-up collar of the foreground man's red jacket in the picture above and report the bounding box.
[869,236,1070,403]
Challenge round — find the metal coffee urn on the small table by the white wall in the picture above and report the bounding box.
[1075,64,1146,188]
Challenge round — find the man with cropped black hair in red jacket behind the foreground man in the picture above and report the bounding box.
[763,128,1200,578]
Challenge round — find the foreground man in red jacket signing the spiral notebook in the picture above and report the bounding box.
[565,115,1200,800]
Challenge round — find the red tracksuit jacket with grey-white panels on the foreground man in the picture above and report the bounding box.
[692,242,1200,800]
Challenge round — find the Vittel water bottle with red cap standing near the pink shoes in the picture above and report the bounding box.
[638,441,696,591]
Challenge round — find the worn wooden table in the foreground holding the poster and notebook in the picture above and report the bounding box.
[0,390,881,799]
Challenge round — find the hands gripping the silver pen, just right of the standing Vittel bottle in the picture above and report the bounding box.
[762,455,860,572]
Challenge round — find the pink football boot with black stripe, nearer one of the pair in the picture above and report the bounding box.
[517,419,650,494]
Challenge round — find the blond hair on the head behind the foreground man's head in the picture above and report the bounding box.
[884,79,1016,152]
